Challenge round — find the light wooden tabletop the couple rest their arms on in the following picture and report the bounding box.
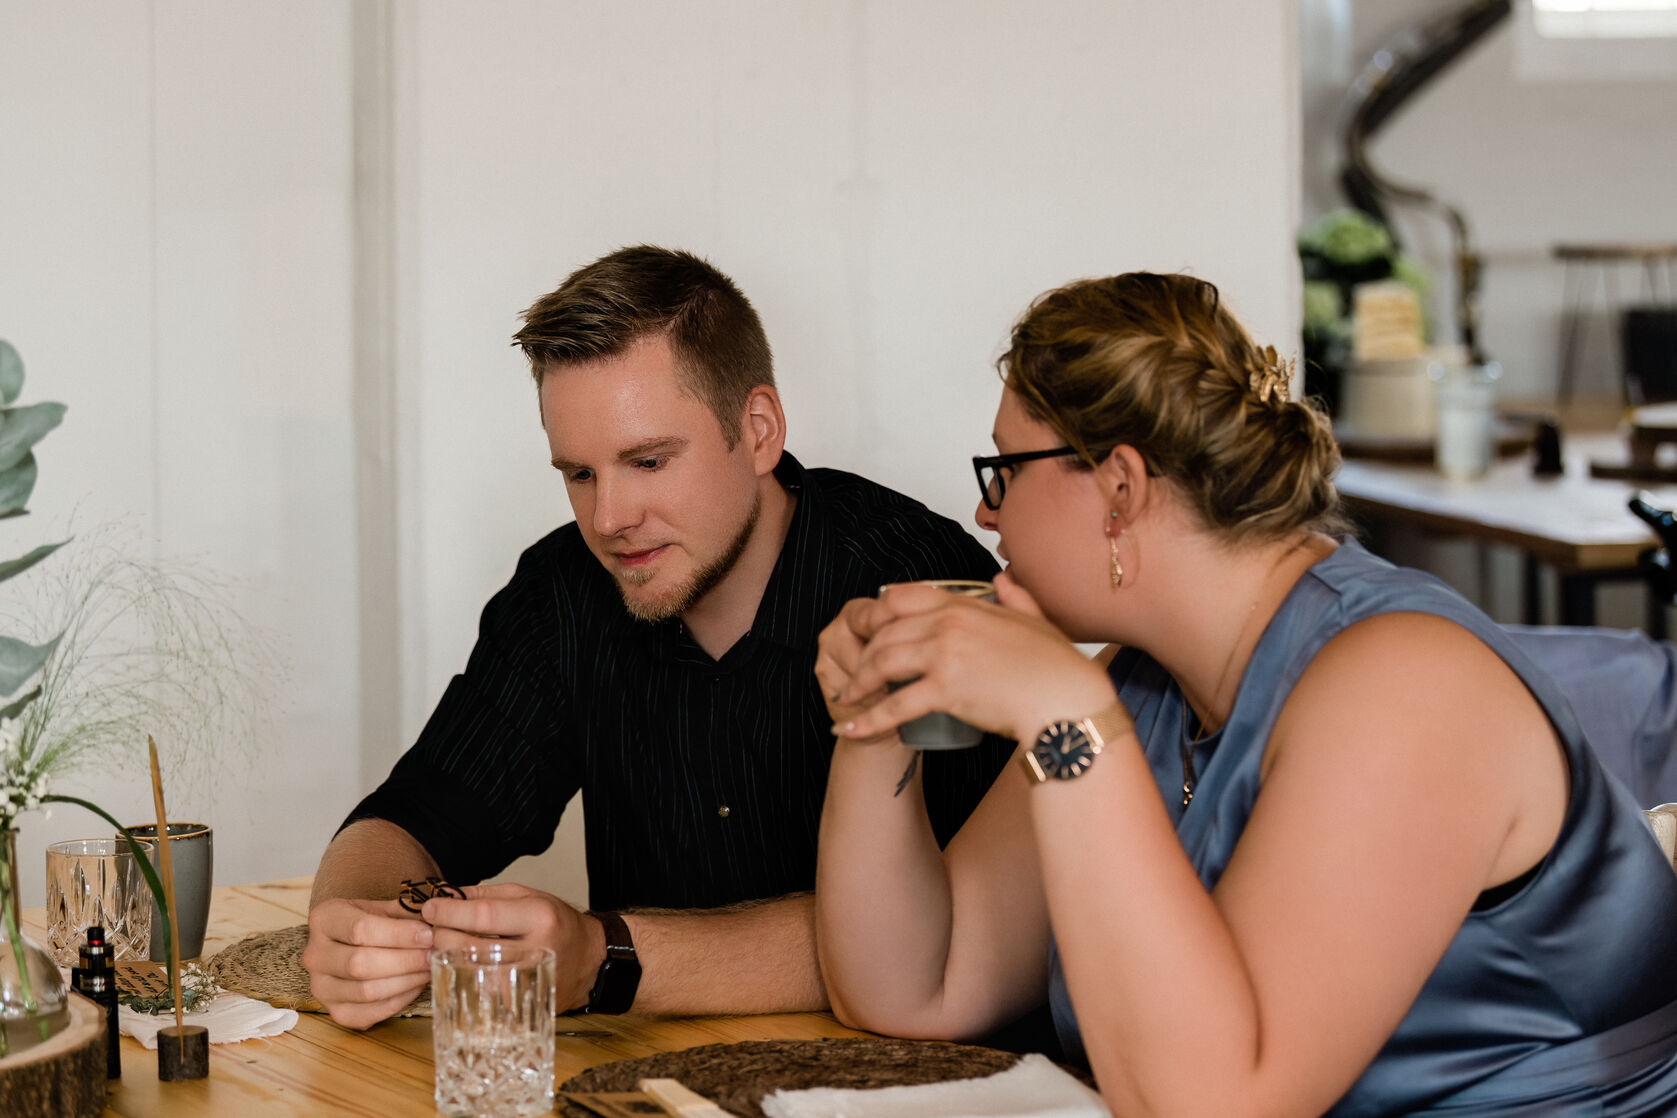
[22,877,867,1118]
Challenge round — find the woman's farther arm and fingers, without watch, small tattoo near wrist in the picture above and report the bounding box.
[815,602,1048,1039]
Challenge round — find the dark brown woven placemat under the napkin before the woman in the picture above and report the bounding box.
[558,1038,1020,1118]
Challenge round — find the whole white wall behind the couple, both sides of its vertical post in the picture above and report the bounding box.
[0,0,1298,895]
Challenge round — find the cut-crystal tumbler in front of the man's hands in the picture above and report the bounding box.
[431,944,557,1118]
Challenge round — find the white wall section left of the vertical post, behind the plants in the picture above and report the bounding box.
[0,0,359,902]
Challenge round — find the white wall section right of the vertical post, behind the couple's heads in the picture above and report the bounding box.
[404,0,1296,892]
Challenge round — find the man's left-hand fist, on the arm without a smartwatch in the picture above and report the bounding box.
[304,898,433,1029]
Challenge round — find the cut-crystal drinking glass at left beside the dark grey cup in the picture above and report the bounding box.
[47,838,158,967]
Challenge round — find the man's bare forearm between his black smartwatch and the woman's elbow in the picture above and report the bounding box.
[624,893,827,1014]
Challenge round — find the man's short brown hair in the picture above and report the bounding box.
[513,245,775,448]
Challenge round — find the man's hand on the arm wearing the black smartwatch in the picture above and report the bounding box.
[423,882,605,1012]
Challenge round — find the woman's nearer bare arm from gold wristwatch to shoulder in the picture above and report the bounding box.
[1031,615,1566,1115]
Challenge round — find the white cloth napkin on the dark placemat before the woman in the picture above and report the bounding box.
[763,1053,1112,1118]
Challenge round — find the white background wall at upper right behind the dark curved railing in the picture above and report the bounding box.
[1303,0,1677,397]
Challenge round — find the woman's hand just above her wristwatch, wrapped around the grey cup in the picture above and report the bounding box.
[817,573,1112,739]
